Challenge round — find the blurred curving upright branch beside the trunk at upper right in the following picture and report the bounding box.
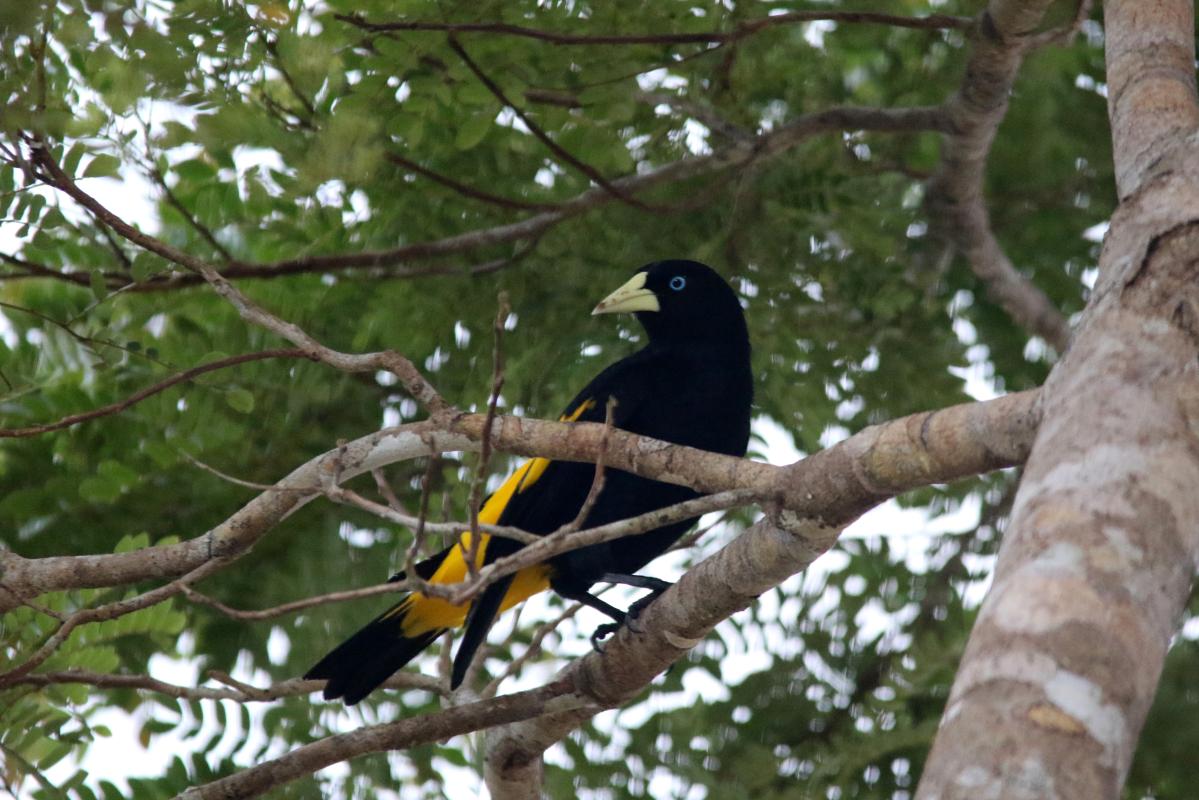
[926,0,1070,353]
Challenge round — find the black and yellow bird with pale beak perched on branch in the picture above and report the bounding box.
[305,259,753,705]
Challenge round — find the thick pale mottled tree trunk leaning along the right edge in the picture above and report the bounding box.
[917,0,1199,800]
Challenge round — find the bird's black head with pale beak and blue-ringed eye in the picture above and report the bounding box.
[591,260,749,347]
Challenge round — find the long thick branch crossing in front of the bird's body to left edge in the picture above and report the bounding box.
[0,391,1040,610]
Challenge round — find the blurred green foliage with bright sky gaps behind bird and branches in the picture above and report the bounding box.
[0,0,1199,799]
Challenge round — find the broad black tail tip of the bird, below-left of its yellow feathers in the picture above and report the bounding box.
[305,612,445,705]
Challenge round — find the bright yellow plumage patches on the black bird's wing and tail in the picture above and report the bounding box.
[386,399,596,637]
